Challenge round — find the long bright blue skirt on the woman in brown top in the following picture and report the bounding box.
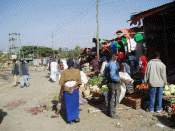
[65,89,79,122]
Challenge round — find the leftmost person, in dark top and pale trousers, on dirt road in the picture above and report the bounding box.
[12,60,19,87]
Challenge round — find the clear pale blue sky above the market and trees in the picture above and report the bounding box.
[0,0,173,51]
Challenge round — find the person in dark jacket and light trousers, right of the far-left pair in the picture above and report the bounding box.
[20,60,30,88]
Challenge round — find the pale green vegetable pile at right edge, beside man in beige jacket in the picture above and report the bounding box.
[163,84,175,96]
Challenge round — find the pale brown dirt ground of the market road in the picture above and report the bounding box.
[0,68,175,131]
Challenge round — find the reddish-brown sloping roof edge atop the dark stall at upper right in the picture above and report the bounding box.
[129,2,175,25]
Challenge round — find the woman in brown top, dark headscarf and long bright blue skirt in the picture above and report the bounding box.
[59,59,82,124]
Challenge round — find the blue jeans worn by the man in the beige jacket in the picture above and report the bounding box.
[148,86,163,111]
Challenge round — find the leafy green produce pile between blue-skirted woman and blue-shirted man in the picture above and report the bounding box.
[88,77,108,93]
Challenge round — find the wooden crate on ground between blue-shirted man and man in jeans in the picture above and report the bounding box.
[121,97,141,109]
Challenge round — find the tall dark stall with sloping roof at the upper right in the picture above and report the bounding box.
[130,1,175,71]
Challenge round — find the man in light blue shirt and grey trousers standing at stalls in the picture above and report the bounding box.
[103,52,123,119]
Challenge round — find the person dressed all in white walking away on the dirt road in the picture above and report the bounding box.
[50,59,58,82]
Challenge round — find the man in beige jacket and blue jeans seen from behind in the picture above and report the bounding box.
[144,51,167,113]
